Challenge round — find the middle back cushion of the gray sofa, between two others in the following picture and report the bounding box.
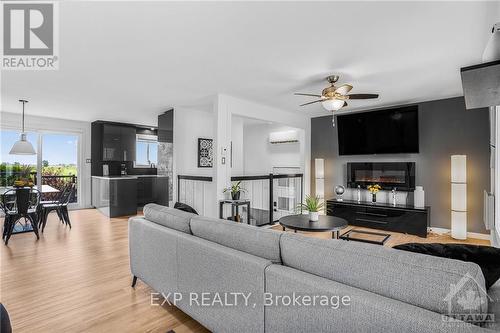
[191,216,281,263]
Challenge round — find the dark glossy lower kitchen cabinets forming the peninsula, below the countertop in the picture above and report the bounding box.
[92,175,168,217]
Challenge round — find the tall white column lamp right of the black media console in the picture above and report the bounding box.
[451,155,467,239]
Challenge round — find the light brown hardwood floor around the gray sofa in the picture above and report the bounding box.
[0,209,489,333]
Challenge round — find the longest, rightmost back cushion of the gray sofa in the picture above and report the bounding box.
[280,233,488,314]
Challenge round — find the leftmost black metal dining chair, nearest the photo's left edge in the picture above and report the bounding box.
[1,188,40,245]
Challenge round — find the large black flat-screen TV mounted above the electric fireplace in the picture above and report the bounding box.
[337,105,418,155]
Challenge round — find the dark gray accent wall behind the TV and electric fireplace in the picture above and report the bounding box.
[311,97,490,233]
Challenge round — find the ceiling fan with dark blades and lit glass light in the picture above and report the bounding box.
[295,75,378,111]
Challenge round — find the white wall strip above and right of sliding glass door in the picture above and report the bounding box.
[0,112,91,208]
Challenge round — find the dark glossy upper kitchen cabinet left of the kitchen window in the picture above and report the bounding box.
[102,124,136,162]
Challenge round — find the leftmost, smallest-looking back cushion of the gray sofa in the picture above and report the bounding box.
[142,204,196,234]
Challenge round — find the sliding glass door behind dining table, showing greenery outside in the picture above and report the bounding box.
[0,129,80,206]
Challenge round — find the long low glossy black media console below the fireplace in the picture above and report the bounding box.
[326,199,431,237]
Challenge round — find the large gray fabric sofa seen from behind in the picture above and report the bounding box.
[129,204,500,333]
